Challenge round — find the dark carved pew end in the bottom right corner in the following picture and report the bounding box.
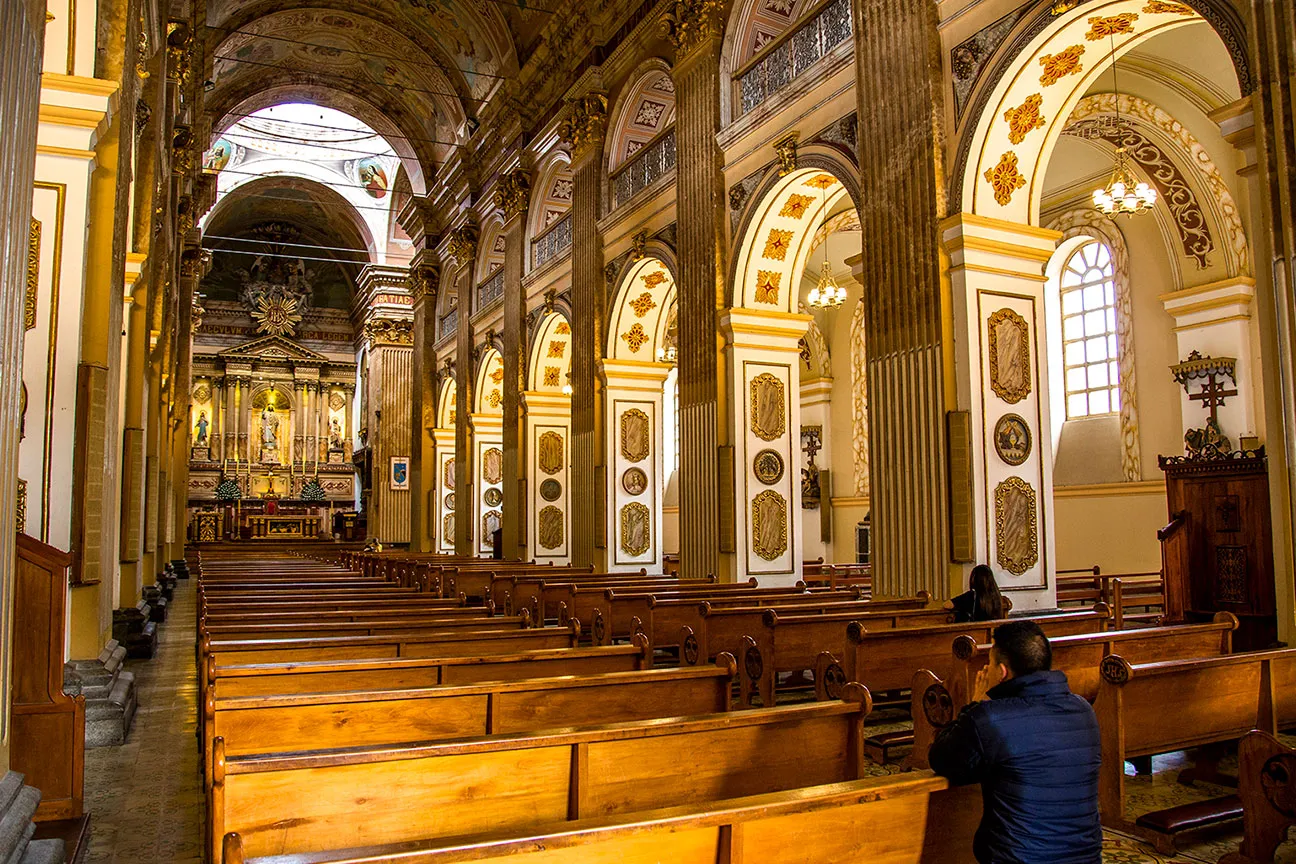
[1220,731,1296,864]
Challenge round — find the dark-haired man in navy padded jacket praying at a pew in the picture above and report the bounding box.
[929,620,1103,864]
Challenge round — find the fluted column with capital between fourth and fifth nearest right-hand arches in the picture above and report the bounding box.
[495,168,531,558]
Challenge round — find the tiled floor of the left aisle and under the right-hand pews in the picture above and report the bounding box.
[75,580,1296,864]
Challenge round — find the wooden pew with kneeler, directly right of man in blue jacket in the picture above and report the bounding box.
[1094,649,1296,848]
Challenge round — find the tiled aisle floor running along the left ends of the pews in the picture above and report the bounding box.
[86,579,202,864]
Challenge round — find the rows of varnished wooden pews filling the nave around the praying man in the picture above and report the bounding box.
[193,548,1296,864]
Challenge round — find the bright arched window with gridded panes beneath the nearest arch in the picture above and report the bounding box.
[1059,240,1121,420]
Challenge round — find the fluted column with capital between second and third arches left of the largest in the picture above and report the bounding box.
[560,93,608,567]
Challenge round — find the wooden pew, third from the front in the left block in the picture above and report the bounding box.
[202,654,737,788]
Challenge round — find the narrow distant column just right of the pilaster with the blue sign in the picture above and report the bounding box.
[410,260,441,552]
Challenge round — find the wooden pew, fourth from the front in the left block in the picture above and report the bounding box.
[202,637,652,703]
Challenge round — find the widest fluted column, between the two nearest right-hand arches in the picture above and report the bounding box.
[850,0,953,597]
